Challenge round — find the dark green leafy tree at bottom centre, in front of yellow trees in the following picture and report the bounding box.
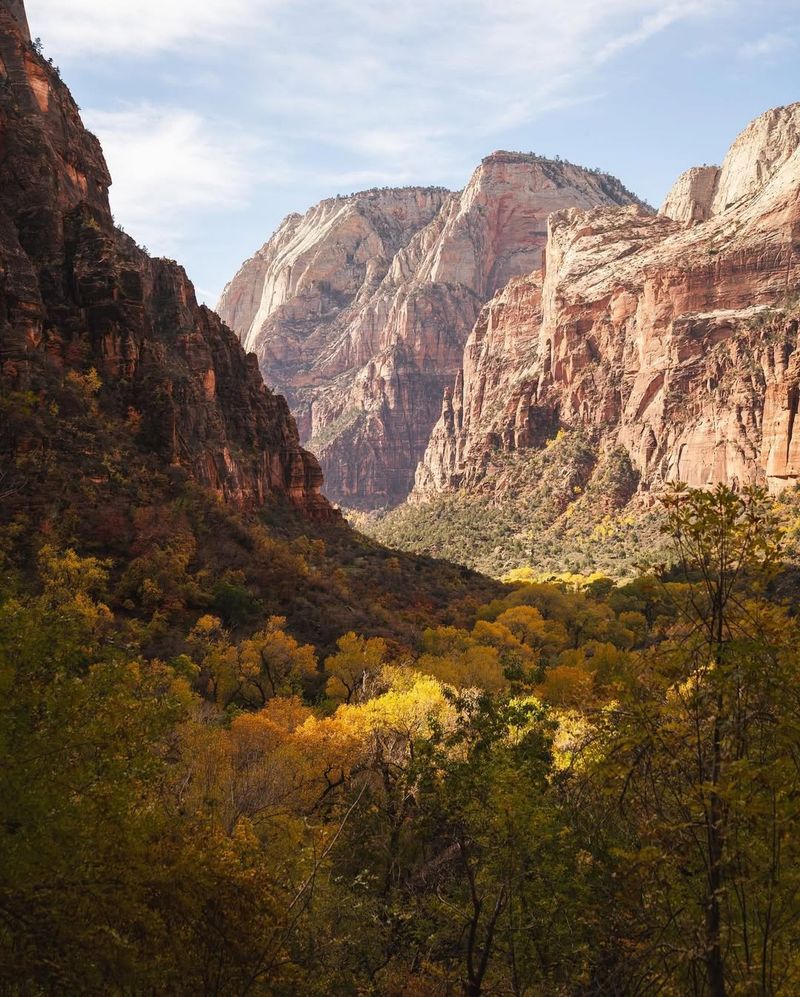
[408,695,588,997]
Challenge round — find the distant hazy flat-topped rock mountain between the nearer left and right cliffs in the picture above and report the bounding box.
[218,159,635,508]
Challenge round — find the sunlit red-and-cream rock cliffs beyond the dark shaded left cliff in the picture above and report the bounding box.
[218,104,800,538]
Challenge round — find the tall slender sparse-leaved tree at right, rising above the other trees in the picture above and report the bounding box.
[588,486,800,997]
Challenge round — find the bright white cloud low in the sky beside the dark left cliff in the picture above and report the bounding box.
[84,104,262,255]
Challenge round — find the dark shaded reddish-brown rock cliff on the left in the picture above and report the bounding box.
[0,2,332,517]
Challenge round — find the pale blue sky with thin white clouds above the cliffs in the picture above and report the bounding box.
[21,0,800,306]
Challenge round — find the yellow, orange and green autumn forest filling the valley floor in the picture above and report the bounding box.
[0,487,800,997]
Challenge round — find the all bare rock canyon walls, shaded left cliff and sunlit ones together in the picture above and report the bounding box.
[7,3,800,566]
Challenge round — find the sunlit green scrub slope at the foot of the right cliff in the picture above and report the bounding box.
[360,430,667,578]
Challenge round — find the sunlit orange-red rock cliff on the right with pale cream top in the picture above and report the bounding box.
[414,104,800,510]
